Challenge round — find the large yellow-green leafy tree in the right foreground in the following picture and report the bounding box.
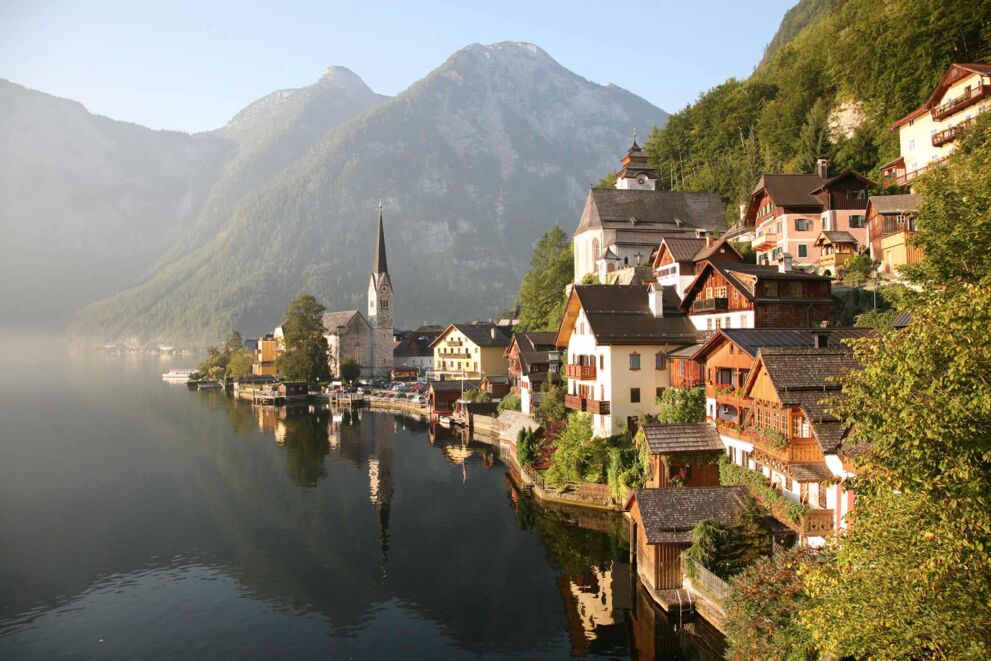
[803,282,991,659]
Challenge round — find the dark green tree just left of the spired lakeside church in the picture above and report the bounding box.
[275,294,330,382]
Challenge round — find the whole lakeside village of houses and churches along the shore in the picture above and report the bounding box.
[165,63,991,640]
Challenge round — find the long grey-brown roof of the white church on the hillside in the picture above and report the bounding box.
[575,188,725,235]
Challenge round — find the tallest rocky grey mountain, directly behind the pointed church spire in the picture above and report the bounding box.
[73,43,667,344]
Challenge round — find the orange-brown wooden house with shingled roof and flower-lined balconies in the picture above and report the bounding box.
[732,347,858,546]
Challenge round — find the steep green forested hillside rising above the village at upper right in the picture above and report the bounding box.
[644,0,991,208]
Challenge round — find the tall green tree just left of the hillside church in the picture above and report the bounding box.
[516,225,575,331]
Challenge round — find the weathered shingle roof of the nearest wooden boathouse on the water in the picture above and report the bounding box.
[634,487,750,544]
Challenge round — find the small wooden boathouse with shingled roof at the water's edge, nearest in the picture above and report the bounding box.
[626,487,750,603]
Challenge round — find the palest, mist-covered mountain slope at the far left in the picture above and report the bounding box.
[0,79,234,326]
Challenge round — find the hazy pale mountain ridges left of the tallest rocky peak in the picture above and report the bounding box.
[0,67,387,326]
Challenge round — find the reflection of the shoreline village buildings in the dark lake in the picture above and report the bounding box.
[246,406,724,660]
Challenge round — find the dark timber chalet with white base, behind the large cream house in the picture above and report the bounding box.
[680,256,837,331]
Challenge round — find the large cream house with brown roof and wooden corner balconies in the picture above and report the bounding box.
[555,284,697,436]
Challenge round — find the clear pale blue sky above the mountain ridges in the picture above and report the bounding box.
[0,0,797,131]
